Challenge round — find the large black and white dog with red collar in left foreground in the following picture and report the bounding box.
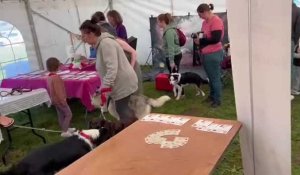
[0,127,110,175]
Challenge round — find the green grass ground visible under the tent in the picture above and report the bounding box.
[0,78,300,175]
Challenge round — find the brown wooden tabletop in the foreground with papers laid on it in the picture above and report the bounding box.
[58,116,241,175]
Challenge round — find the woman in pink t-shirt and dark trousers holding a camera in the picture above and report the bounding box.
[194,3,224,108]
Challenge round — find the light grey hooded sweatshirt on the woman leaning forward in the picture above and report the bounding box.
[96,32,138,101]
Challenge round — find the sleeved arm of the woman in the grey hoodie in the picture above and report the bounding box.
[99,38,118,88]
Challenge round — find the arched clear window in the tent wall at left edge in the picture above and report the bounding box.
[0,20,30,80]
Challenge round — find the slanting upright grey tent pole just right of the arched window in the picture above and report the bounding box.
[24,0,44,69]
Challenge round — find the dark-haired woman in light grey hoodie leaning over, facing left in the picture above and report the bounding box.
[80,20,138,125]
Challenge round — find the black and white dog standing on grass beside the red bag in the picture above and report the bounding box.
[169,72,208,100]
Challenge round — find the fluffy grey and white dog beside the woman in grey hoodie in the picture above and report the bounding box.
[91,92,171,120]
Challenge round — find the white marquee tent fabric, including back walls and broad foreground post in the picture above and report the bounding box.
[0,0,291,175]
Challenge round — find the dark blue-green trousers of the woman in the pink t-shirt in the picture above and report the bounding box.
[203,50,224,103]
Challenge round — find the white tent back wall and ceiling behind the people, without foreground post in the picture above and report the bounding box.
[0,0,226,69]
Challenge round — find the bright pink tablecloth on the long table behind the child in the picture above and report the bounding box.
[1,71,101,111]
